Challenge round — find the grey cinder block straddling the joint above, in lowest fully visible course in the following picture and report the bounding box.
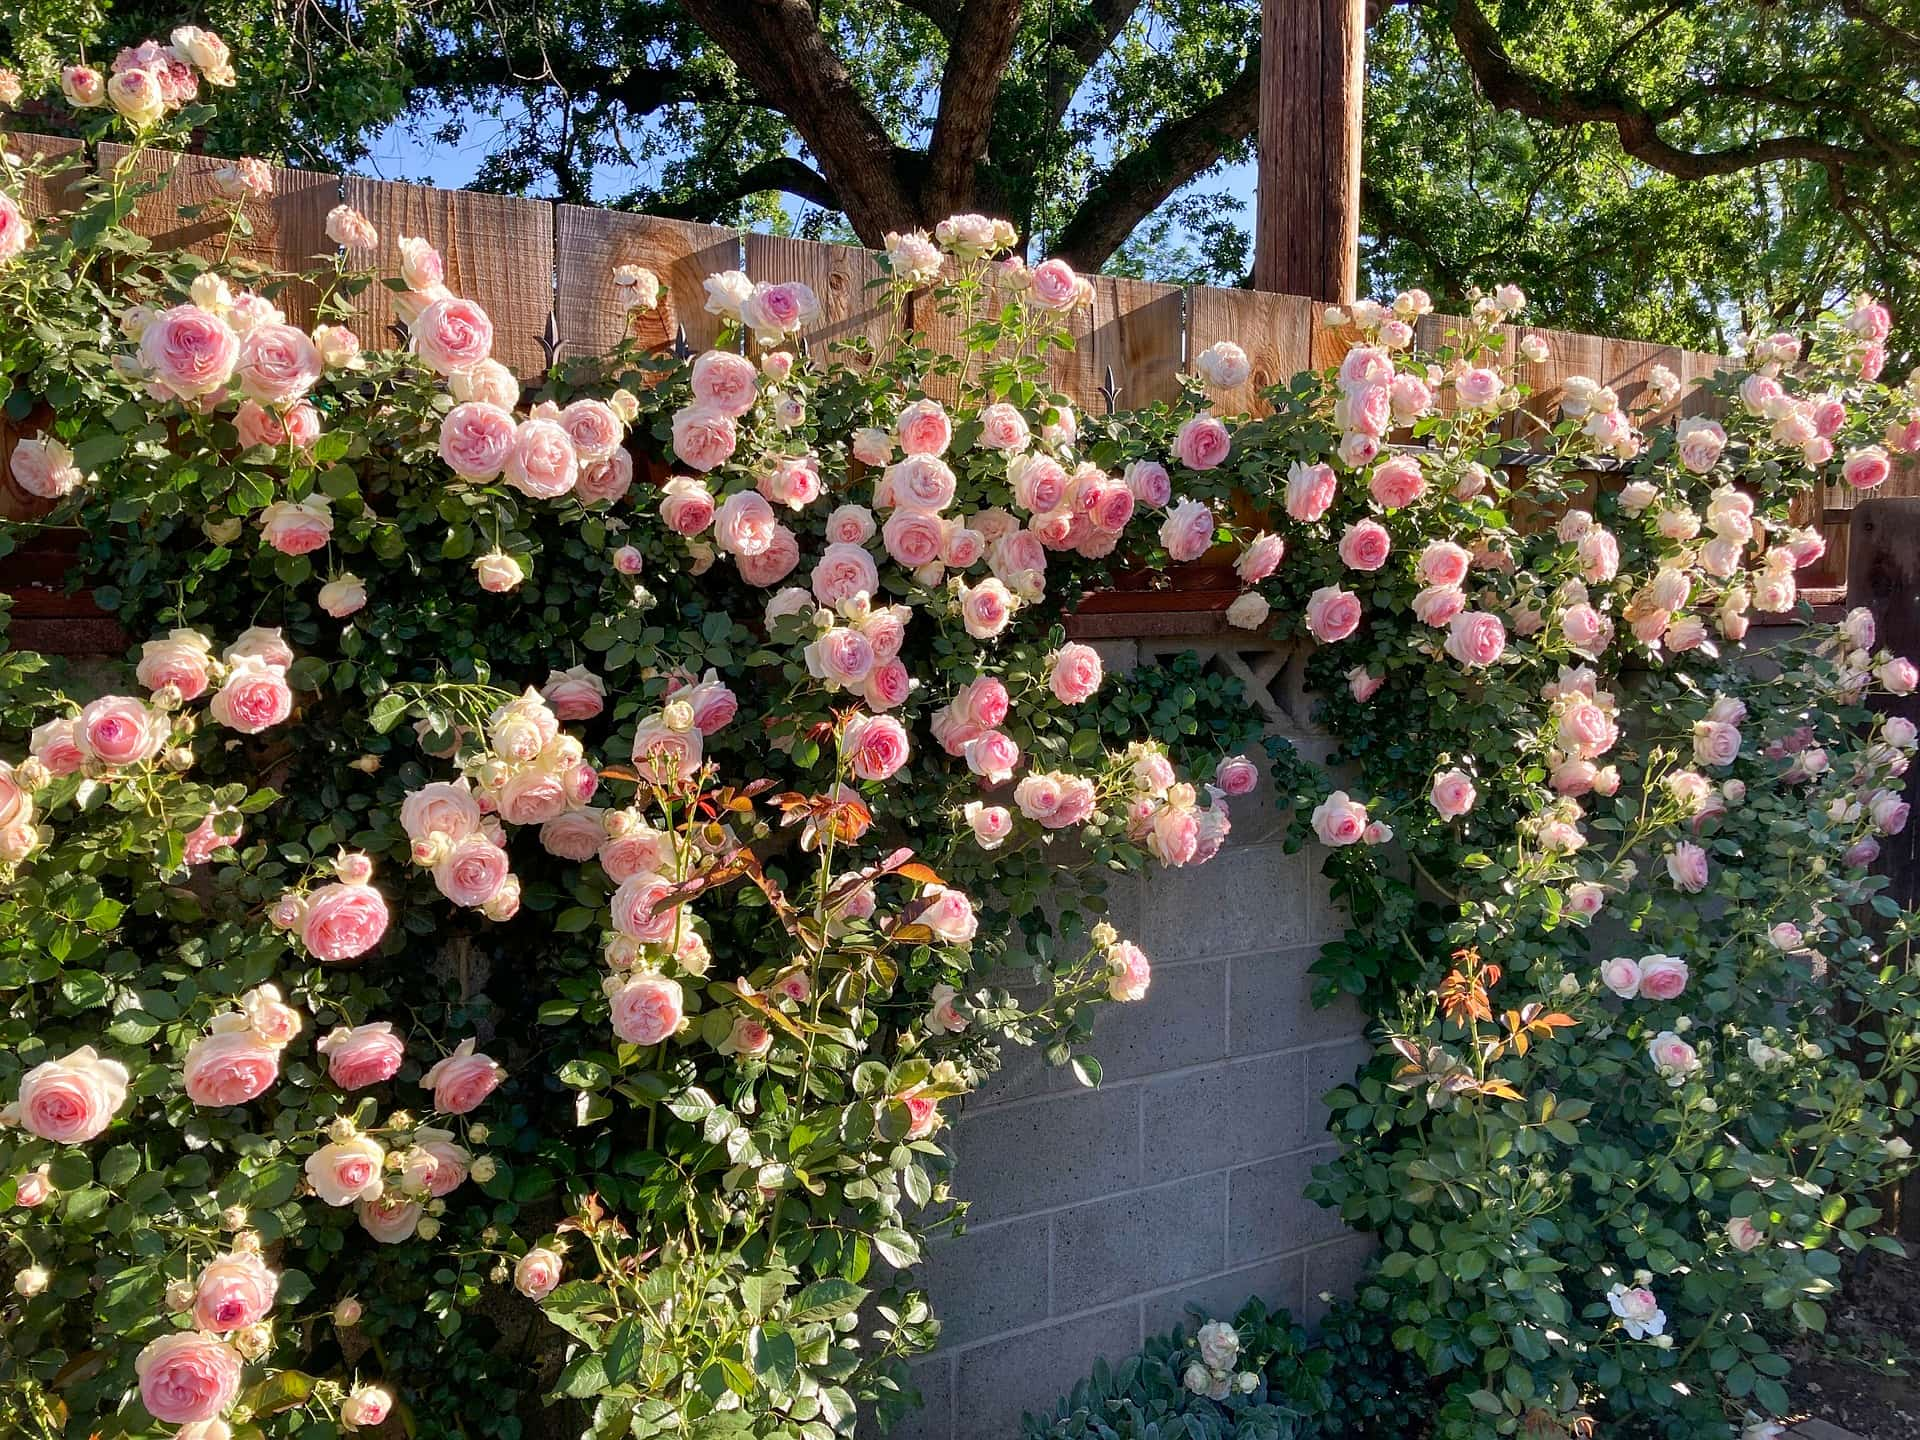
[1052,1175,1227,1315]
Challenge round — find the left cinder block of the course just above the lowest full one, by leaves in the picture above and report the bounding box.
[954,1085,1140,1225]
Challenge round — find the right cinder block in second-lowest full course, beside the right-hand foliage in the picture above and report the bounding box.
[1142,1054,1311,1185]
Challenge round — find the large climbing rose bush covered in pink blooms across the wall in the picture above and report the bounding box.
[0,31,1920,1440]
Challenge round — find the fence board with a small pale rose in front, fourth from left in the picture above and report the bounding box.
[553,205,739,359]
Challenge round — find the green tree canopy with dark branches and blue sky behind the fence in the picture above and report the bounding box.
[0,0,1920,346]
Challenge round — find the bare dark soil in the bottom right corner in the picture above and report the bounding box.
[1789,1240,1920,1440]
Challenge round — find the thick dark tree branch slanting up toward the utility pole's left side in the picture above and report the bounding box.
[1052,44,1260,271]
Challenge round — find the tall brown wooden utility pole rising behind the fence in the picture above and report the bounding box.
[1254,0,1367,305]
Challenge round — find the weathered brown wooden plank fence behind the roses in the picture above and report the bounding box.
[0,134,1889,643]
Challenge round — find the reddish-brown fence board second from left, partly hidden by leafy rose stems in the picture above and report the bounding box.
[98,144,340,326]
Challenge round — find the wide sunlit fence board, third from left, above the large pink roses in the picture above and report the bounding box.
[346,175,553,380]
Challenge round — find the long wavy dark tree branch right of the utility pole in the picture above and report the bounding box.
[1452,0,1882,180]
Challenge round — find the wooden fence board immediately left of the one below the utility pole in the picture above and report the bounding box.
[1046,275,1187,415]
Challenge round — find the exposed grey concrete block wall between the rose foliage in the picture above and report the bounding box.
[895,641,1369,1440]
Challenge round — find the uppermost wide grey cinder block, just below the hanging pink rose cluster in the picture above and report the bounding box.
[1140,845,1327,960]
